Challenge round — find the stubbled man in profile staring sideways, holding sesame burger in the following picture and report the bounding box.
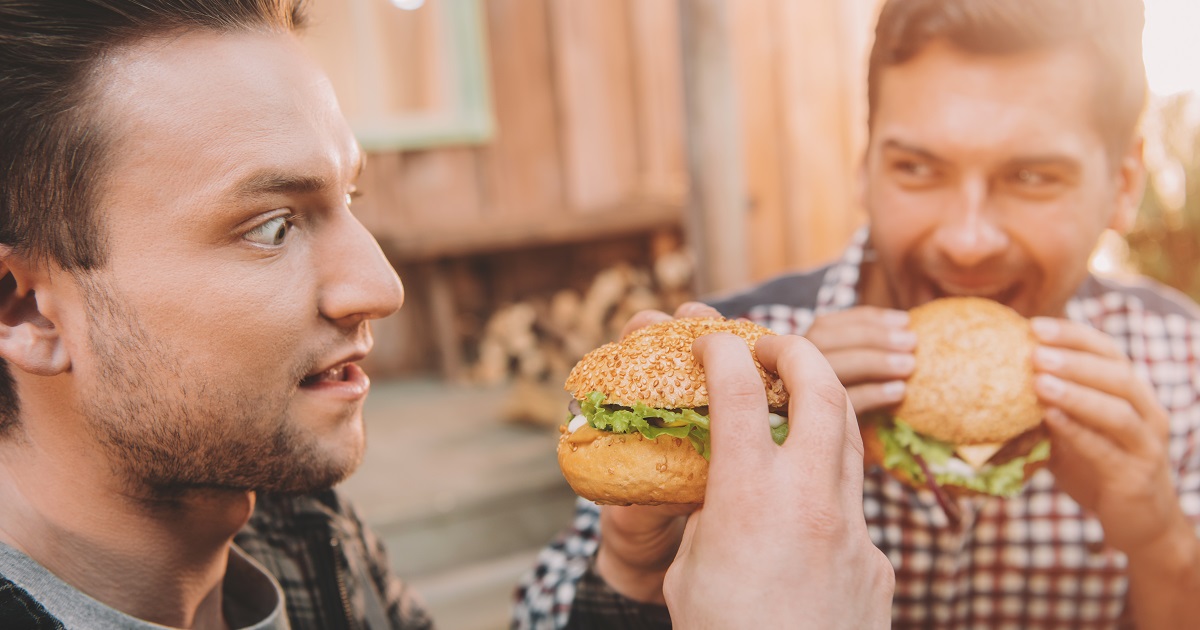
[0,0,892,630]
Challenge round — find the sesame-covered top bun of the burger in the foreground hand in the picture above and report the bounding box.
[566,317,787,409]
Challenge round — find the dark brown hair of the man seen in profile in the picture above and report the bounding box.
[0,0,305,431]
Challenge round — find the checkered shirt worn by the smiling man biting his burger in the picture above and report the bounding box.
[512,229,1200,630]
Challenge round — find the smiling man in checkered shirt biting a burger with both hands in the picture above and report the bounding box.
[515,0,1200,628]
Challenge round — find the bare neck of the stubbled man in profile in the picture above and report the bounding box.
[0,417,254,629]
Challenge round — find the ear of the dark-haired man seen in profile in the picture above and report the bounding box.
[0,247,71,376]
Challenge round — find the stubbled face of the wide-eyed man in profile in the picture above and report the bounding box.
[62,32,403,492]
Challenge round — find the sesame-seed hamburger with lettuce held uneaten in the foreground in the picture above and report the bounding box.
[558,318,787,505]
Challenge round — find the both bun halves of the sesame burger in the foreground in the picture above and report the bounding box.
[558,318,787,505]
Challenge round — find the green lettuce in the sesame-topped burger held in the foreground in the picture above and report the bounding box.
[580,391,787,460]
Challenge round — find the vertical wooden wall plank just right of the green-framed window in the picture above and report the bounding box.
[479,0,564,220]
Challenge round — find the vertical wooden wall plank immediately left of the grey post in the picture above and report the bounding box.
[629,0,688,200]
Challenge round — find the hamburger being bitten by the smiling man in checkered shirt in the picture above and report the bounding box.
[862,298,1050,508]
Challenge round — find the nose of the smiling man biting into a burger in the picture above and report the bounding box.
[934,181,1009,268]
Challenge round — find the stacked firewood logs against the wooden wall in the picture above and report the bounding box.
[472,250,692,422]
